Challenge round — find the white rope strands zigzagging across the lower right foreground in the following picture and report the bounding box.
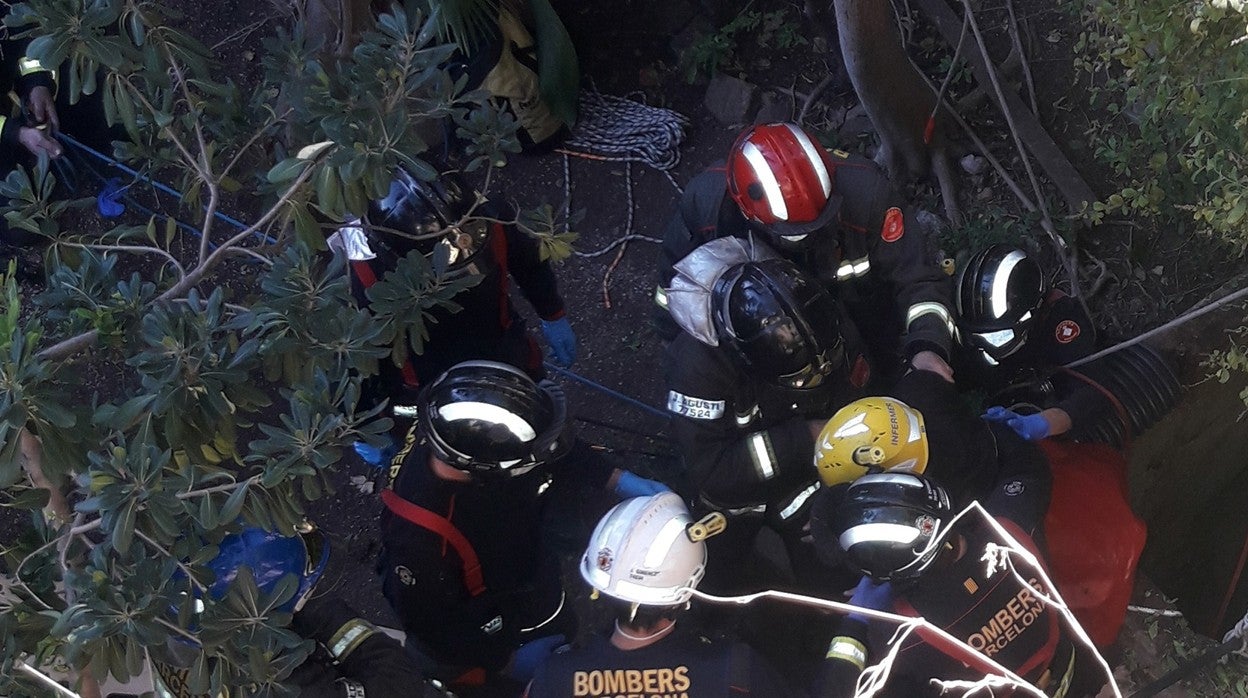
[686,502,1128,698]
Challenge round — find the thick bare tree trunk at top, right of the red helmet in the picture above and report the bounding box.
[834,0,961,225]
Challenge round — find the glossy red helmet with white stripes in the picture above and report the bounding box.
[728,124,839,241]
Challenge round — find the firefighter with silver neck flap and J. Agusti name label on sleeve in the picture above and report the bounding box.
[664,237,867,591]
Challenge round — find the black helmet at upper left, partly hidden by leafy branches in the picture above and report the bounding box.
[368,167,489,266]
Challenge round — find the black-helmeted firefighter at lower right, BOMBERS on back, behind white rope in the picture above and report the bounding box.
[814,471,1099,698]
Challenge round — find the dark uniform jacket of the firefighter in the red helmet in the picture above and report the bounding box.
[655,150,952,360]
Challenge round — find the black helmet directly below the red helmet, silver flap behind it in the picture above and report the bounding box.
[711,260,845,388]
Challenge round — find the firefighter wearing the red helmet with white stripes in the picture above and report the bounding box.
[655,124,953,377]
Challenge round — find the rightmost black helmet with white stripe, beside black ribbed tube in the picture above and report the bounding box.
[957,245,1045,361]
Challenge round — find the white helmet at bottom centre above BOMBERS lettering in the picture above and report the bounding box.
[580,492,706,606]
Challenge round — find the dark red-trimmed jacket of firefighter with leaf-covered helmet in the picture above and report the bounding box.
[351,212,564,404]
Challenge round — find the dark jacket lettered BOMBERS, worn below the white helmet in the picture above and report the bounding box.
[525,628,800,698]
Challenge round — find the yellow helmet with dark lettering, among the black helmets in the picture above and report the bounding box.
[815,397,927,487]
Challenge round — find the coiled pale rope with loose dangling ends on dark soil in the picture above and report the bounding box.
[555,89,689,307]
